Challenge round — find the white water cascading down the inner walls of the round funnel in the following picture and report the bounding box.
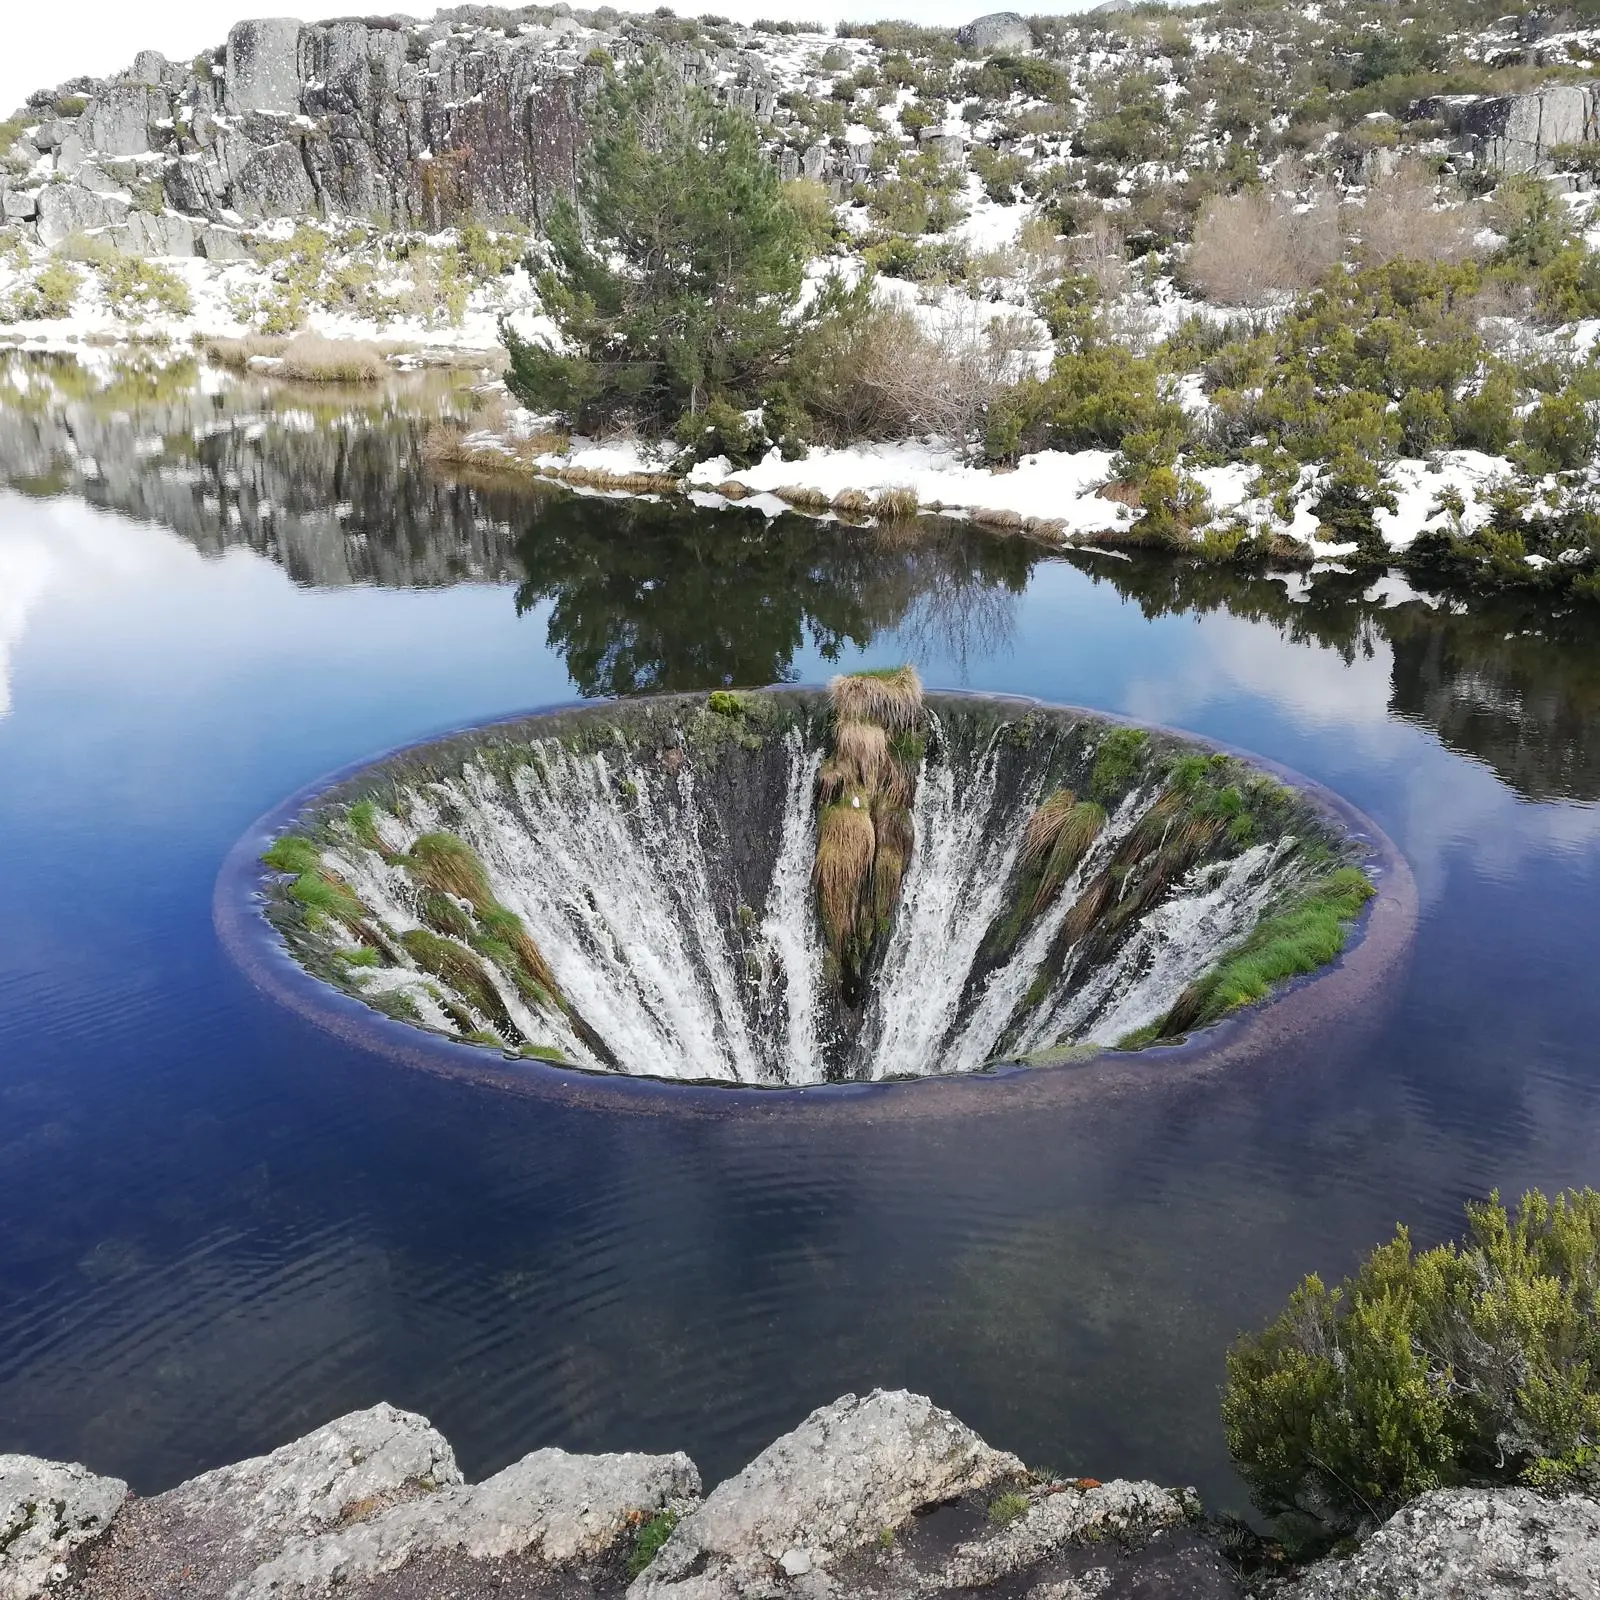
[268,704,1346,1085]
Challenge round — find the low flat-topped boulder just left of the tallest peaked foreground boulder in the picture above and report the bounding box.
[230,1450,699,1600]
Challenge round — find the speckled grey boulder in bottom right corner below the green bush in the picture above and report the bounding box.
[1285,1490,1600,1600]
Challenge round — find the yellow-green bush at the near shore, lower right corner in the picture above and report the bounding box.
[1222,1189,1600,1546]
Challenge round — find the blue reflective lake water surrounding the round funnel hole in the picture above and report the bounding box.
[0,363,1600,1506]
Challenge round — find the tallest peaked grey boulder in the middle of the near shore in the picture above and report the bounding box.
[629,1389,1024,1600]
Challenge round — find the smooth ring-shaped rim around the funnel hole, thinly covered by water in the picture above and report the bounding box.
[211,683,1418,1115]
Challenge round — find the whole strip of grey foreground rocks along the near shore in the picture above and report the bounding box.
[0,1390,1600,1600]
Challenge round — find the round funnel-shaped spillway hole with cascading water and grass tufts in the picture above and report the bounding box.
[218,681,1410,1088]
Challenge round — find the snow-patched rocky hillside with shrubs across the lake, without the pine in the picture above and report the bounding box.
[0,0,1600,594]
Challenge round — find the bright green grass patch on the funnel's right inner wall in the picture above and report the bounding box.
[1158,867,1376,1038]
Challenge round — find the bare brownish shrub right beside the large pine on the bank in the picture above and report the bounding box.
[805,304,1038,445]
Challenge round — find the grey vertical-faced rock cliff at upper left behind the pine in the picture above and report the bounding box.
[0,6,800,259]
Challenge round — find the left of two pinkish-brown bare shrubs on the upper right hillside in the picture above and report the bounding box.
[1184,190,1341,306]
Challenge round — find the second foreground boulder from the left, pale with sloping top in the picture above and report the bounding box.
[83,1405,461,1600]
